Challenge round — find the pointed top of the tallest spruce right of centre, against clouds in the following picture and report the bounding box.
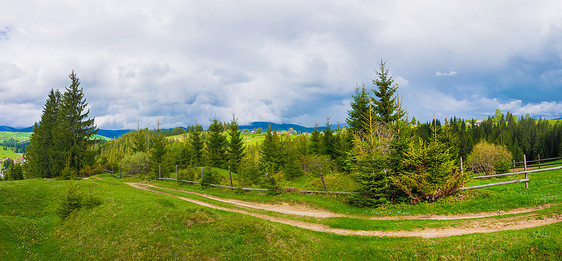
[371,60,400,123]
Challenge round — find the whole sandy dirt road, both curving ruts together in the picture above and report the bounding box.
[126,183,562,238]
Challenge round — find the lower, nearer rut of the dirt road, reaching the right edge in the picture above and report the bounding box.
[126,183,562,238]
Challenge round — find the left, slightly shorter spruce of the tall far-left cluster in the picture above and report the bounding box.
[25,90,61,178]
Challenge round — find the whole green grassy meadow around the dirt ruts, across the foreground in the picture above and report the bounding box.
[0,168,562,260]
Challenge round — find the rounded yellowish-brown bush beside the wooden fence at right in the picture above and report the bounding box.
[467,141,512,175]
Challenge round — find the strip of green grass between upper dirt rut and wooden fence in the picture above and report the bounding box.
[147,166,562,216]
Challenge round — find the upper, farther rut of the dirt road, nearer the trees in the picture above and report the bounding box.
[142,185,551,220]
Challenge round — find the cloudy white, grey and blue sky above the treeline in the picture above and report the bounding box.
[0,0,562,129]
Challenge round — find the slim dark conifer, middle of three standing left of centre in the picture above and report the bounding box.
[207,117,227,168]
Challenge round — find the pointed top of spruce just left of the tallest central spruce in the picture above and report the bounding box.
[346,84,371,133]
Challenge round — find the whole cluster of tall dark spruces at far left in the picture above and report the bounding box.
[26,71,98,178]
